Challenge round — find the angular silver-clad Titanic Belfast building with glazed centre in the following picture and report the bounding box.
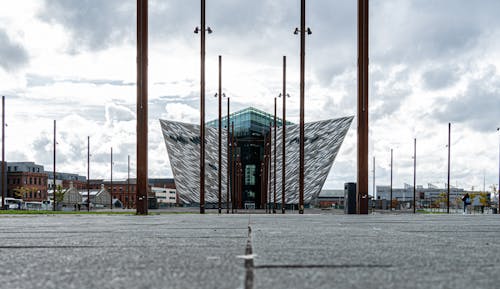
[160,107,353,208]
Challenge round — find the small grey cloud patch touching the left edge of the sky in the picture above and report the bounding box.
[0,29,29,71]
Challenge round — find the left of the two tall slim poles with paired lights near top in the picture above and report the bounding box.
[194,0,212,214]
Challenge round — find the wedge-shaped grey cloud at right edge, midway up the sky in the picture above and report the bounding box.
[433,67,500,132]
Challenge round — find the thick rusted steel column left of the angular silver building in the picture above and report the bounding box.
[136,0,148,215]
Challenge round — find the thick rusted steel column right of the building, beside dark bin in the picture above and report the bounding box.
[356,0,370,214]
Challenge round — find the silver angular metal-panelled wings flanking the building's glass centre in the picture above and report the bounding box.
[160,117,353,204]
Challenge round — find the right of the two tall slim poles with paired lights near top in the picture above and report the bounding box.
[299,0,306,214]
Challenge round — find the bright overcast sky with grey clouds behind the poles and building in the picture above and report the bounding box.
[0,0,500,192]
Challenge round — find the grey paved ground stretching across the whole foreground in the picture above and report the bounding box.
[0,213,500,289]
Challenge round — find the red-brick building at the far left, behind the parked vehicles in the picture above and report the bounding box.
[7,162,48,201]
